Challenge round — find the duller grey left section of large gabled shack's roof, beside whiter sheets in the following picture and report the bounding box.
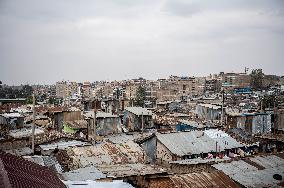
[156,131,219,156]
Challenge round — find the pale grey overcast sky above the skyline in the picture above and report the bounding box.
[0,0,284,85]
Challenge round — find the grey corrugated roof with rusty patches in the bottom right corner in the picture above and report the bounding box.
[212,156,284,187]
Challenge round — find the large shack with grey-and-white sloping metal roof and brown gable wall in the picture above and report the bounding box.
[153,130,243,164]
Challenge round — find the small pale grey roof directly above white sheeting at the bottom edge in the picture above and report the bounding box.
[63,166,106,181]
